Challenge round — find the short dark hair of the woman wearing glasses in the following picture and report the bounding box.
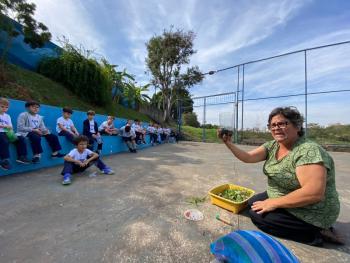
[268,106,305,137]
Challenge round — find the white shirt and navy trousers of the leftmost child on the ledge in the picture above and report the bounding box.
[0,113,27,160]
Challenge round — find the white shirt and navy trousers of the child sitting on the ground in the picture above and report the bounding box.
[61,148,107,175]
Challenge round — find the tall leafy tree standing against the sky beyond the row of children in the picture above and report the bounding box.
[146,28,203,121]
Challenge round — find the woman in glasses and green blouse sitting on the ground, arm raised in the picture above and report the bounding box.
[219,107,342,246]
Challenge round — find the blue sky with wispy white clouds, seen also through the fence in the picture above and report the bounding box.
[31,0,350,128]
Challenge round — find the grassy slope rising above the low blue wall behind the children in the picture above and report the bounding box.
[0,64,150,121]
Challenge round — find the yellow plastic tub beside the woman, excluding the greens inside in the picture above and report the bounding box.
[209,184,255,214]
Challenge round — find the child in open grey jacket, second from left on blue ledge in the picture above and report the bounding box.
[17,101,64,163]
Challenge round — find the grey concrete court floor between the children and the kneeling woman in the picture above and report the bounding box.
[0,142,350,263]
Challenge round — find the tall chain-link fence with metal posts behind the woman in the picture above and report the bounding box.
[178,41,350,146]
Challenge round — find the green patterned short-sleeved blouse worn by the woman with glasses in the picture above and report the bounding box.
[263,137,340,228]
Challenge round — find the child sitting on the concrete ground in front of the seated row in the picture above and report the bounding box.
[61,135,114,185]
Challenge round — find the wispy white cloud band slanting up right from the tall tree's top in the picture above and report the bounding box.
[191,1,305,65]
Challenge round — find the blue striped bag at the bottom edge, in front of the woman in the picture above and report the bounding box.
[210,230,299,263]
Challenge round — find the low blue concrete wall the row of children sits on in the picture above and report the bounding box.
[0,100,150,176]
